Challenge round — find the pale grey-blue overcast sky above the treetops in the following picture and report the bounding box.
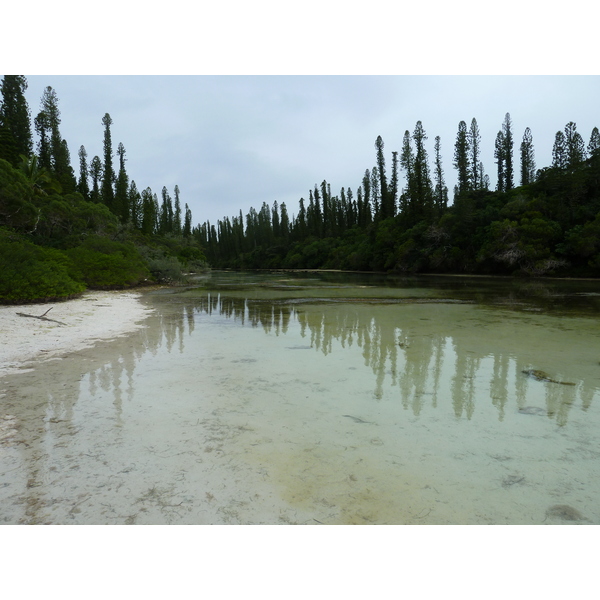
[16,75,600,225]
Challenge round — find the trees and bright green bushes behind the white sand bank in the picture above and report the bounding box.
[0,75,206,303]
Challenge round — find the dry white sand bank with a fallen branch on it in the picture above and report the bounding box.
[0,291,153,377]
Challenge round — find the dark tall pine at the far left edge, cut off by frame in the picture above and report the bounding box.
[0,75,33,165]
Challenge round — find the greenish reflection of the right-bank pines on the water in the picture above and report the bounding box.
[182,293,598,425]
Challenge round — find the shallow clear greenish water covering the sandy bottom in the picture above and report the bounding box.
[0,273,600,524]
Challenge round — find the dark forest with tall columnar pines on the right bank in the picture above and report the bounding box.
[198,114,600,277]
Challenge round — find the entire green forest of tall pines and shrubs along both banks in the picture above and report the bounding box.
[0,75,600,303]
